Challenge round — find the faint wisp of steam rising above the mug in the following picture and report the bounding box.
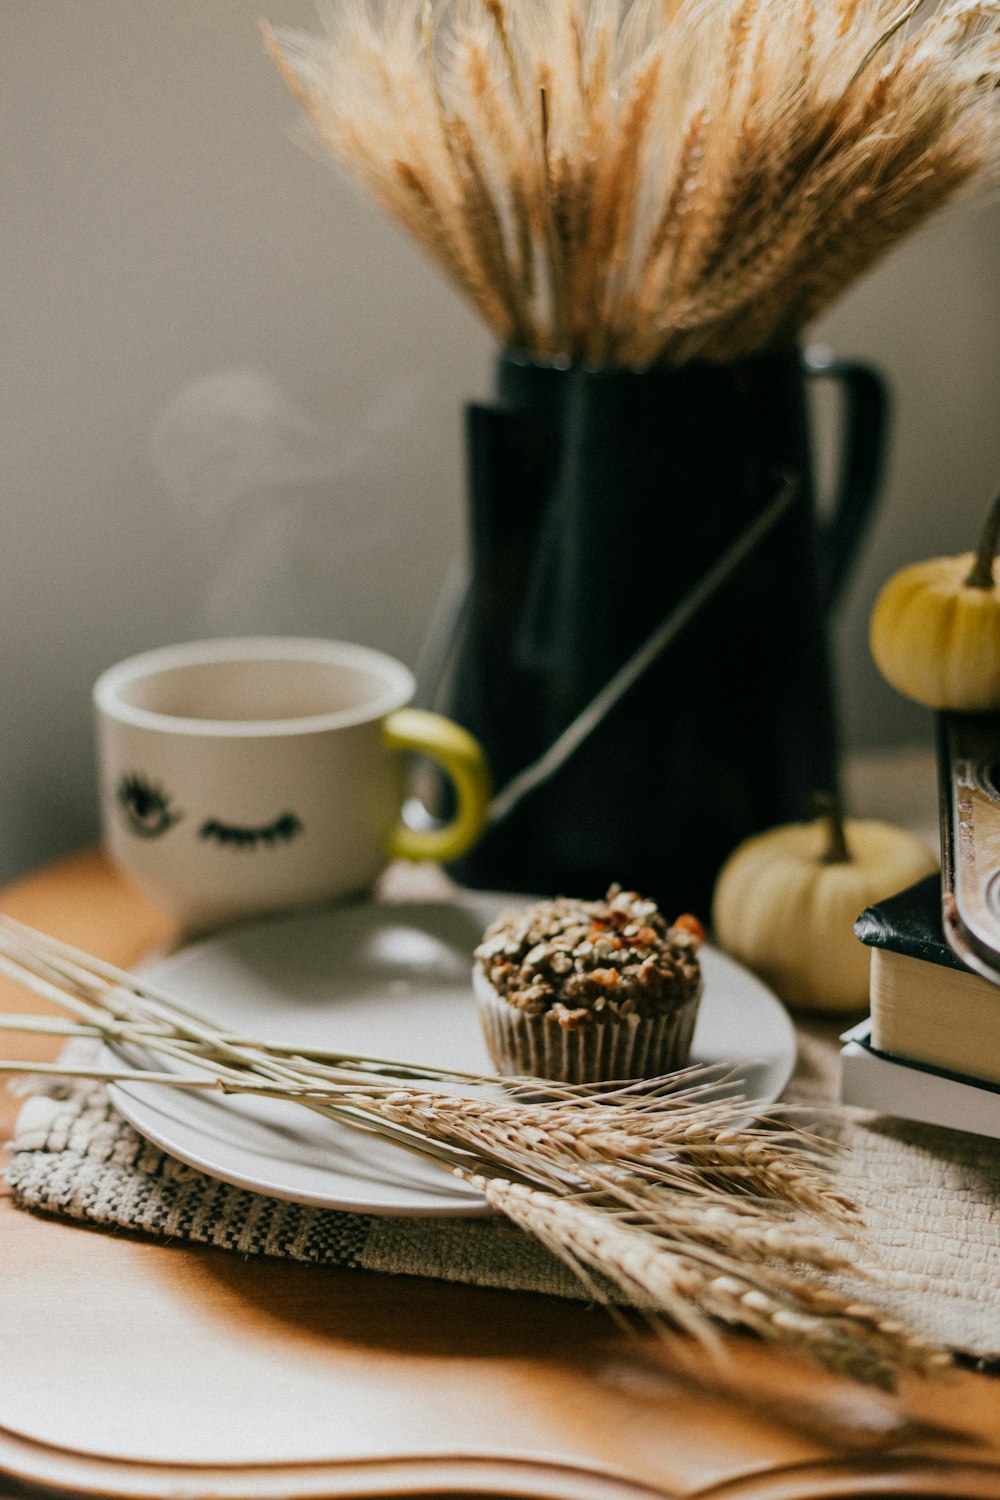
[150,366,423,636]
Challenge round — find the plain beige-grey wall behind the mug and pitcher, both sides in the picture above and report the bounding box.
[0,0,1000,875]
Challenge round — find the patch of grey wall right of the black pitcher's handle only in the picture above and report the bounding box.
[816,204,1000,746]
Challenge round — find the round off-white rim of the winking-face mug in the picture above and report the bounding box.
[93,636,417,740]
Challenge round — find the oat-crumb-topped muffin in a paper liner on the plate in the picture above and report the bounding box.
[474,885,702,1083]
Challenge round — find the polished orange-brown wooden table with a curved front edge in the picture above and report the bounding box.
[0,854,1000,1500]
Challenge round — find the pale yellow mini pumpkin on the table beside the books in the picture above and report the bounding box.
[712,800,937,1016]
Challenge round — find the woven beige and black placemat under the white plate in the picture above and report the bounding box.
[7,1026,1000,1362]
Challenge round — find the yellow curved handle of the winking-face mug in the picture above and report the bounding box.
[382,708,490,861]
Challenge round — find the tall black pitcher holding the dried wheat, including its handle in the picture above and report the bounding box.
[447,351,886,915]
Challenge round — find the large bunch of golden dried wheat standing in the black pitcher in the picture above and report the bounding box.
[264,0,1000,368]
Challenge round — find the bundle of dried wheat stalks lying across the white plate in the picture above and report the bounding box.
[0,917,949,1388]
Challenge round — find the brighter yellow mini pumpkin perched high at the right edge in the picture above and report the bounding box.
[868,497,1000,713]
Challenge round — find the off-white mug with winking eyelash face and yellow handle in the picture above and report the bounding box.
[94,636,489,932]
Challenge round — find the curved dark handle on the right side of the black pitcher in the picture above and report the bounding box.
[802,348,889,611]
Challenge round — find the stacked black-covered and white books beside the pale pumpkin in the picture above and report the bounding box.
[841,875,1000,1139]
